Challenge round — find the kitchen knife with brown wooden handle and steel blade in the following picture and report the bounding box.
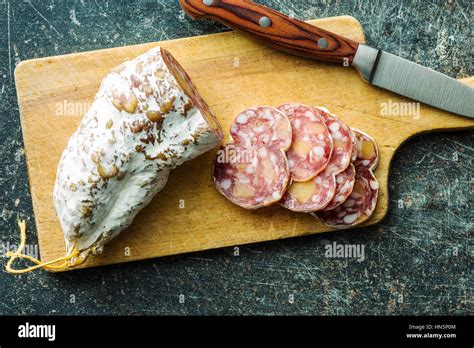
[179,0,474,118]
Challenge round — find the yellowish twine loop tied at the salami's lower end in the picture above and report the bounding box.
[5,219,88,274]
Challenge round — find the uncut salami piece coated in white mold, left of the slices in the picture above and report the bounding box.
[54,47,222,255]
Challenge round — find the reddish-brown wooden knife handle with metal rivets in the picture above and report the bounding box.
[179,0,359,64]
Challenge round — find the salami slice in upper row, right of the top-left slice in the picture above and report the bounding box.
[278,103,333,181]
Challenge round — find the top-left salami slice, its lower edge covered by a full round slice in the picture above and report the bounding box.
[230,106,292,151]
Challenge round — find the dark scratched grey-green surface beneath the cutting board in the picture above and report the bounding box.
[0,0,474,315]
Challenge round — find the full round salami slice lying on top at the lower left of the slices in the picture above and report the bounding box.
[214,144,290,209]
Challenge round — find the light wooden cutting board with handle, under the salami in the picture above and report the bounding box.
[15,16,474,267]
